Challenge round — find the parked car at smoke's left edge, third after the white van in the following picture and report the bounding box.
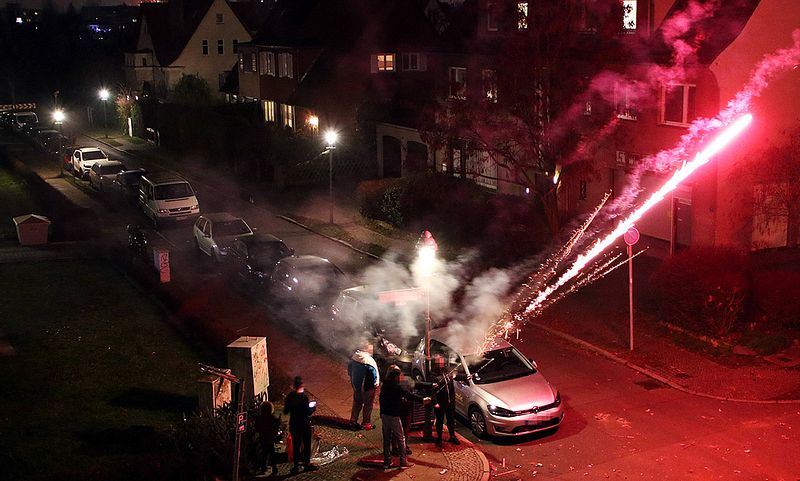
[269,255,347,311]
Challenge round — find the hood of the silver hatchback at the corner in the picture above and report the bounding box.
[473,372,556,411]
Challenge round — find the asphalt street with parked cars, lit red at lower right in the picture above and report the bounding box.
[7,132,800,480]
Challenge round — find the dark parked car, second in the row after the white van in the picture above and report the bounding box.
[228,233,294,286]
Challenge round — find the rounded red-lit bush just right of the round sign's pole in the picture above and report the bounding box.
[648,247,749,337]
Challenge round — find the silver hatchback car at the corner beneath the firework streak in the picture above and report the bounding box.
[412,328,564,437]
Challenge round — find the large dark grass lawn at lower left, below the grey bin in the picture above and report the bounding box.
[0,260,200,480]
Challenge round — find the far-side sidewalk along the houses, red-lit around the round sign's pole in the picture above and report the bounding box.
[90,130,800,403]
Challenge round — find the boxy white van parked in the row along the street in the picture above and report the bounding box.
[139,172,200,228]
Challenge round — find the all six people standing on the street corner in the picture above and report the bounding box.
[255,344,460,476]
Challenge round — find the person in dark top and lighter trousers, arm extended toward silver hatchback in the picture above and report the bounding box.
[379,370,414,469]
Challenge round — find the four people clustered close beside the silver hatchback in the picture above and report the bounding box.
[347,344,460,469]
